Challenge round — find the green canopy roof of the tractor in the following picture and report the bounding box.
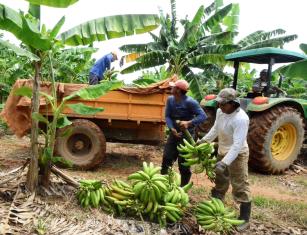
[225,47,307,64]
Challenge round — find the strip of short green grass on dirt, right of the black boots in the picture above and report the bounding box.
[253,196,307,227]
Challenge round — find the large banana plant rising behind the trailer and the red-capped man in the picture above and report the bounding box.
[120,0,239,100]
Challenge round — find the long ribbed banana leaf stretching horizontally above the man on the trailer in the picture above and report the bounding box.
[58,14,159,46]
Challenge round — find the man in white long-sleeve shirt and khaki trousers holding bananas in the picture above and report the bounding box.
[197,88,251,231]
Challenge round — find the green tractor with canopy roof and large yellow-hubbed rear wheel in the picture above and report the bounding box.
[200,47,307,174]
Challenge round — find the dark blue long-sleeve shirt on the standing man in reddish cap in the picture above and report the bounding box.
[165,95,207,130]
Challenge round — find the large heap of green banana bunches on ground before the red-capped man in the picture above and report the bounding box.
[77,162,192,227]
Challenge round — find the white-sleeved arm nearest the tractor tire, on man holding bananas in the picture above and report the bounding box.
[222,119,249,166]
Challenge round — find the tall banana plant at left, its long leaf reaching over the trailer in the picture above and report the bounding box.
[0,0,159,191]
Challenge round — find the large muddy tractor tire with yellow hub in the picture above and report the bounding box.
[248,106,304,174]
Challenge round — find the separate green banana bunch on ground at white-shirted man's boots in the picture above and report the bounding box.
[195,198,244,232]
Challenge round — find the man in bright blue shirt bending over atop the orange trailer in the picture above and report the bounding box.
[89,52,117,85]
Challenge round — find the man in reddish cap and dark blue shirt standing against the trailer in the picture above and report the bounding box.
[161,75,206,186]
